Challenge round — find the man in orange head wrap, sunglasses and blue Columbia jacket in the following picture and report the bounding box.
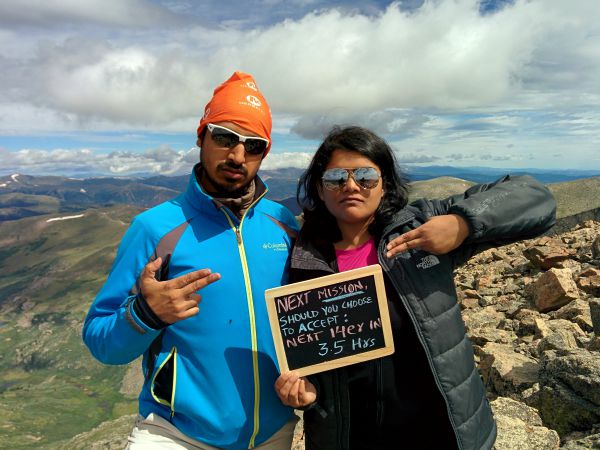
[83,72,297,450]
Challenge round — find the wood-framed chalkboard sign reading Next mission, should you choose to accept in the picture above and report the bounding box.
[265,264,394,376]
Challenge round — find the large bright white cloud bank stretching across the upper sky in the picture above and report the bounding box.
[1,0,600,131]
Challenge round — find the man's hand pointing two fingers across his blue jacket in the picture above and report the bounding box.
[140,257,221,324]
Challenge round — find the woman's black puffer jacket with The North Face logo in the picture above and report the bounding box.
[291,176,556,450]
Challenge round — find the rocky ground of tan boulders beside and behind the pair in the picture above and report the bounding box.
[66,221,600,450]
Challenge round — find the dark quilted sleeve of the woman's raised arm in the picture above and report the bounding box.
[412,175,556,264]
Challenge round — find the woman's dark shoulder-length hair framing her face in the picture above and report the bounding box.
[296,126,408,242]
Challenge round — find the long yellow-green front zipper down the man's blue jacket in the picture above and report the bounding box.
[220,190,267,449]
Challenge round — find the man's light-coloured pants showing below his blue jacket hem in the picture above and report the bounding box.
[126,413,297,450]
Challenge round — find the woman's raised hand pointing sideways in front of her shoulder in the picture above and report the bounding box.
[386,214,469,258]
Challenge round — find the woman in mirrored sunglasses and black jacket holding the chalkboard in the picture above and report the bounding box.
[275,127,555,450]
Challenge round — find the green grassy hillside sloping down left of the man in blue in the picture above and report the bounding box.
[0,207,142,449]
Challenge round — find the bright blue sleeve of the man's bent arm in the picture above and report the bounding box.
[83,215,161,364]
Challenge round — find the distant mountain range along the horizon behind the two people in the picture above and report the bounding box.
[0,166,600,221]
